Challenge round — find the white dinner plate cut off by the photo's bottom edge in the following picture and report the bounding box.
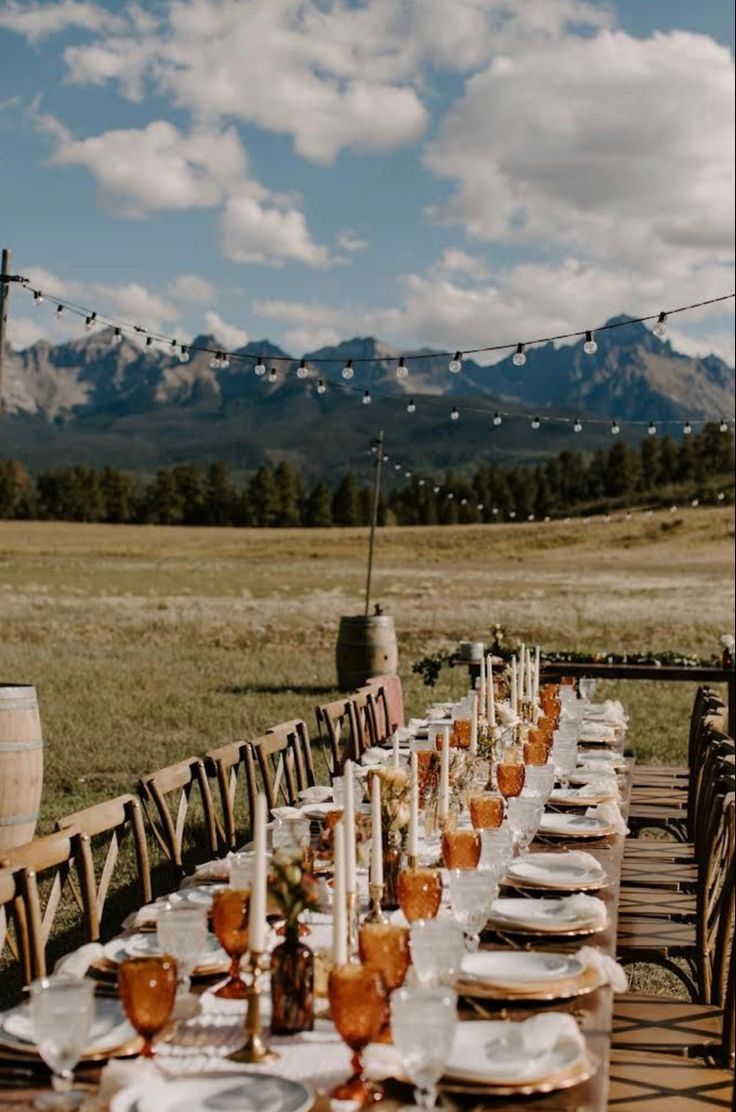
[110,1072,315,1112]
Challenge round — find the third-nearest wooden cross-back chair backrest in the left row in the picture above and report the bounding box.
[56,794,151,935]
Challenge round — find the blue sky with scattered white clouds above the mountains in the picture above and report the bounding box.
[0,0,734,364]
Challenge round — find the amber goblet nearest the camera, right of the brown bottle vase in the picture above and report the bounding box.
[327,965,388,1105]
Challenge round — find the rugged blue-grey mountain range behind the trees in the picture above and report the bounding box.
[0,318,735,477]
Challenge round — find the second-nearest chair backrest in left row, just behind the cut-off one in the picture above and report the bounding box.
[0,831,85,980]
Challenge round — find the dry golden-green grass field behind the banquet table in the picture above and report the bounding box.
[0,509,734,830]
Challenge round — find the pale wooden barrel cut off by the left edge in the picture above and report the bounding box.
[0,684,43,852]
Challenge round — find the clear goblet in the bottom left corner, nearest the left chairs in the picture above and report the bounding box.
[29,976,95,1109]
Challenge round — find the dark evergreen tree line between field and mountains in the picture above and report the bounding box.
[0,424,734,528]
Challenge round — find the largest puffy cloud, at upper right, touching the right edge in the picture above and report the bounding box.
[426,31,734,275]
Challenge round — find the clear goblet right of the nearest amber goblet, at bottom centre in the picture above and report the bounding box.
[391,989,457,1109]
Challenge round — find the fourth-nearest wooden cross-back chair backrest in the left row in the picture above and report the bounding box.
[138,757,218,880]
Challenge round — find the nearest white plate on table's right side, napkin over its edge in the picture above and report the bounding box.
[445,1013,585,1085]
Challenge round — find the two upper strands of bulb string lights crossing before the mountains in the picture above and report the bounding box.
[19,277,736,435]
